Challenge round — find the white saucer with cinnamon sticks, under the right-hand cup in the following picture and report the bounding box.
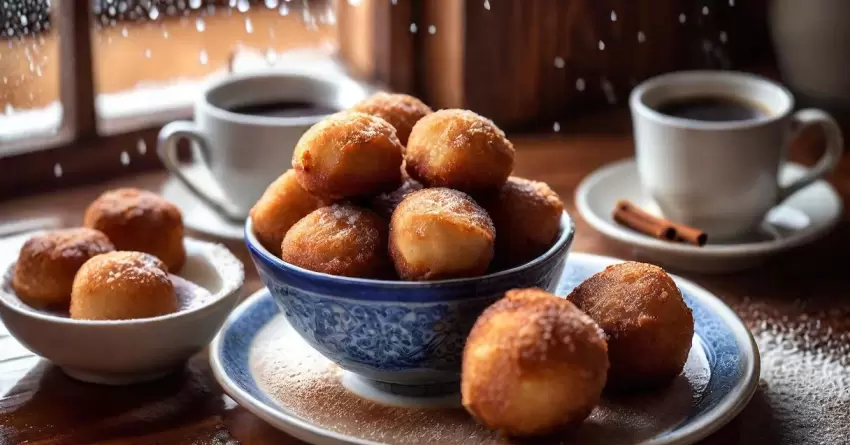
[576,158,842,273]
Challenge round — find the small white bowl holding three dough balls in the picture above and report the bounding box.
[0,238,245,385]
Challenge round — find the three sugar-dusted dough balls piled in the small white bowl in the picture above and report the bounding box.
[12,188,186,320]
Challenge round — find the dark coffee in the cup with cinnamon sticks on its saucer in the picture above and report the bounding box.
[655,96,768,122]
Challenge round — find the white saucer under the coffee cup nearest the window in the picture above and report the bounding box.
[159,165,245,240]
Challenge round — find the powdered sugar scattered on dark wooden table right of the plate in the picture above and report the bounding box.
[738,299,850,445]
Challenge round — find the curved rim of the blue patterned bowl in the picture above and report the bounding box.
[245,211,576,289]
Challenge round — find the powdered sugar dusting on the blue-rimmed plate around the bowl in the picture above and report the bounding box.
[250,315,709,445]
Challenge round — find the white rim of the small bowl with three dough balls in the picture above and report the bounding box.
[0,237,245,326]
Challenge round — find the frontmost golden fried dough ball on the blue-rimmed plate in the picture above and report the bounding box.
[461,289,608,436]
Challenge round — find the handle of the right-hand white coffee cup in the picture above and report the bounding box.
[777,108,844,202]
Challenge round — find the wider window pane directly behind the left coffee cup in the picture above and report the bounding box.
[92,0,336,133]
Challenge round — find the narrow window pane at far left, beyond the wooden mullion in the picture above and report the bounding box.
[0,0,62,156]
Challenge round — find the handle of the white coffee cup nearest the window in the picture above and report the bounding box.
[156,121,245,222]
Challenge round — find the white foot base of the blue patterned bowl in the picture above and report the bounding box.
[341,371,461,408]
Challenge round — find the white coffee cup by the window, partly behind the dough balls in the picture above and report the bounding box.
[157,73,368,220]
